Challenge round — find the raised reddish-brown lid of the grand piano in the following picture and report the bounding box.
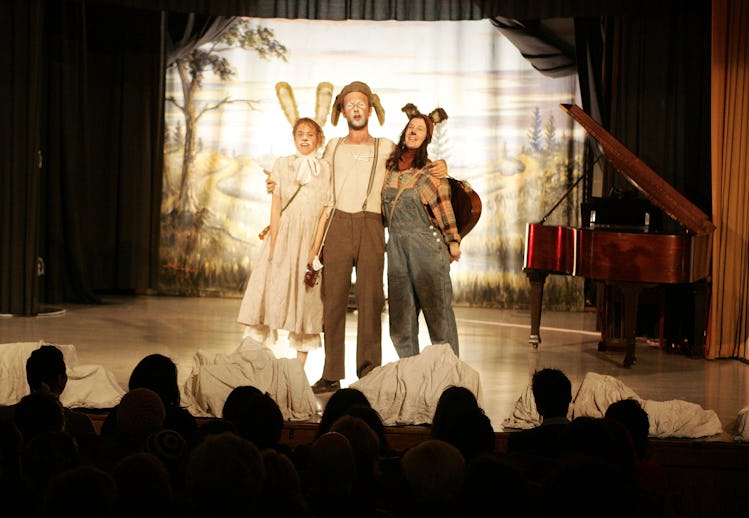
[560,104,715,234]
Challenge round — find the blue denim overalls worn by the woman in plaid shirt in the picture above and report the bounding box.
[382,169,458,358]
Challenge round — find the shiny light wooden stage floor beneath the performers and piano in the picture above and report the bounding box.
[0,296,749,440]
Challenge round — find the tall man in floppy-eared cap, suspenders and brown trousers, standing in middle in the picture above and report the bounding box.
[300,81,447,393]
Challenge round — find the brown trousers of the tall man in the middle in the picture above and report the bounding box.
[322,210,385,380]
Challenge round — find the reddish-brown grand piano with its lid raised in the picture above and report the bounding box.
[523,104,715,367]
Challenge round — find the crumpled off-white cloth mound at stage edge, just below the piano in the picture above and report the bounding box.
[502,372,723,438]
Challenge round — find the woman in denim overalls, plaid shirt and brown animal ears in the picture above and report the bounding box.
[382,104,460,358]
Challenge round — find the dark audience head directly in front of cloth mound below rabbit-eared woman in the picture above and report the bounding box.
[222,386,283,450]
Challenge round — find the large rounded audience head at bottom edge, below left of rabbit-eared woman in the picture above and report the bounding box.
[187,432,265,516]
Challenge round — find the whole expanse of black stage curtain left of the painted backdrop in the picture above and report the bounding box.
[0,0,164,316]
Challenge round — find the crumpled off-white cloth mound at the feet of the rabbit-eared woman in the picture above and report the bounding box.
[183,346,318,421]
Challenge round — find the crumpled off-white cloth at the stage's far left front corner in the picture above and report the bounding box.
[0,341,125,409]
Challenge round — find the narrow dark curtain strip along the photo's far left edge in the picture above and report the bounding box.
[0,0,45,316]
